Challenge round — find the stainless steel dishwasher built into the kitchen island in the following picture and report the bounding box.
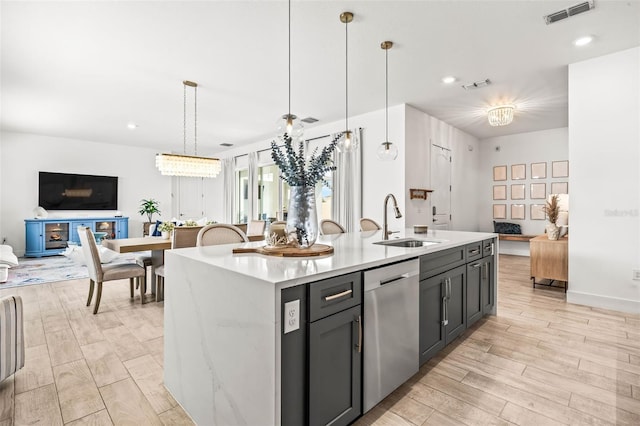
[363,259,420,412]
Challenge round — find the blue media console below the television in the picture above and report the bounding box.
[24,217,129,257]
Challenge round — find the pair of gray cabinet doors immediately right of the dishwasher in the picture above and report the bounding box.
[419,265,467,364]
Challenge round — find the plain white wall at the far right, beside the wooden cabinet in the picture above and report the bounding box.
[567,47,640,313]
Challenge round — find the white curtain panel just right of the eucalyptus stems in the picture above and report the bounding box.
[331,128,362,232]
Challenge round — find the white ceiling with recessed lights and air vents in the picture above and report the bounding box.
[0,0,640,154]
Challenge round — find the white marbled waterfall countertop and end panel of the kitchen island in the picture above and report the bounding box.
[164,230,497,425]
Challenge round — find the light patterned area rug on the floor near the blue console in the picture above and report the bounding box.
[0,253,140,289]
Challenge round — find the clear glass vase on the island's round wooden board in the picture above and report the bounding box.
[286,186,318,248]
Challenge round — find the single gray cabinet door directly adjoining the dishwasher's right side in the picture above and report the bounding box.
[419,274,446,365]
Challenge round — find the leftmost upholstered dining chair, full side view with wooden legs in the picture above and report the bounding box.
[78,227,146,315]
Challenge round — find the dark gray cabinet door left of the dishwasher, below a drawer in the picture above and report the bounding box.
[308,305,362,426]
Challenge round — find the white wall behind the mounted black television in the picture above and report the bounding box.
[0,132,171,256]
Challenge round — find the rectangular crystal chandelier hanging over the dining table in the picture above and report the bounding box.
[156,80,222,178]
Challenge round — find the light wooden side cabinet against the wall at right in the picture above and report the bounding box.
[529,235,569,292]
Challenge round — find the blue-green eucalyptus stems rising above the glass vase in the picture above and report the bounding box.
[271,133,342,186]
